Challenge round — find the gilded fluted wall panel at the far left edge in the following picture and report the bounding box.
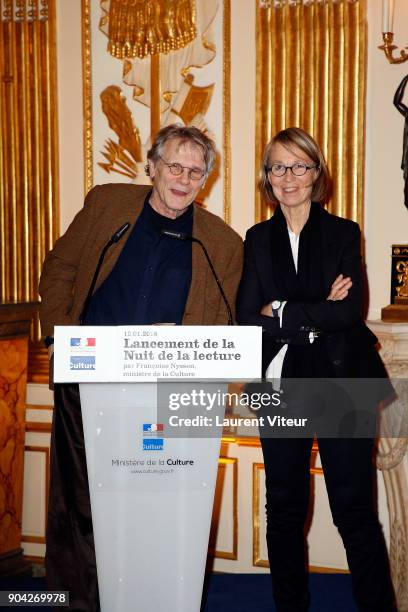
[0,0,59,314]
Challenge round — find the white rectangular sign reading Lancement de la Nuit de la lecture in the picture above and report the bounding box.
[54,325,262,382]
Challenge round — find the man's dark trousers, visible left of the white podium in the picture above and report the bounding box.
[45,384,99,612]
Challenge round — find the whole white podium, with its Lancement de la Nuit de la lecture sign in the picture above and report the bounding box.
[55,326,261,612]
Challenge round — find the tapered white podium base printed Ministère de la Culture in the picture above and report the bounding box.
[80,381,225,612]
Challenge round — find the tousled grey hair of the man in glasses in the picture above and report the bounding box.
[145,123,216,176]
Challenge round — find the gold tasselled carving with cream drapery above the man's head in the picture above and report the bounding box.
[99,0,218,127]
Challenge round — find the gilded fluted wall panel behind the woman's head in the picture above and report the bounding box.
[255,0,366,225]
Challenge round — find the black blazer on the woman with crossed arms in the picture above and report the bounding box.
[237,208,387,378]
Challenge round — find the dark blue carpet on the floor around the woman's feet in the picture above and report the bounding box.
[0,574,357,612]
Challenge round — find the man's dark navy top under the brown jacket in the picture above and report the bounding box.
[84,194,193,325]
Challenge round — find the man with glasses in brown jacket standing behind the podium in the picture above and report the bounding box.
[40,125,242,612]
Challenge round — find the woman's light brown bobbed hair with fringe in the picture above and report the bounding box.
[258,127,331,204]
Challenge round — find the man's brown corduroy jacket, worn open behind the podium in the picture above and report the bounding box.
[39,184,242,336]
